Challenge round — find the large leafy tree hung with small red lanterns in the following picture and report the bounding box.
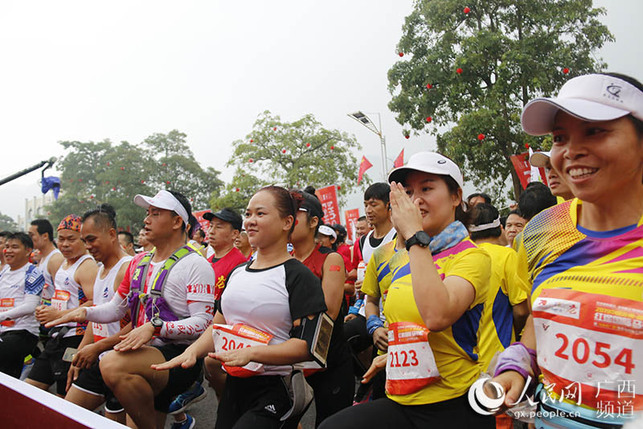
[388,0,613,198]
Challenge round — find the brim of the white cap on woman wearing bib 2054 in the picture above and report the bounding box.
[520,98,630,136]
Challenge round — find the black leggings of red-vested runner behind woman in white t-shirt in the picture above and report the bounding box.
[306,355,355,427]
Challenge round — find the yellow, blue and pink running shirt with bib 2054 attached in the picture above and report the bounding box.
[517,199,643,410]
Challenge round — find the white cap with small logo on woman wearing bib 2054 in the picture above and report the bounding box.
[521,74,643,136]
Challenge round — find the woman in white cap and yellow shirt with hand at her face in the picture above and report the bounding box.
[322,152,495,429]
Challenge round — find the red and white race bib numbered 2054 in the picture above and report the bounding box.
[532,289,643,409]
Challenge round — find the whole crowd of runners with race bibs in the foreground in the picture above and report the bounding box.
[0,74,643,429]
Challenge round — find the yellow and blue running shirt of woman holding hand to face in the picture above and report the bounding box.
[384,237,491,405]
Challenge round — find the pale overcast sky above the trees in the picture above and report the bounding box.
[0,0,643,218]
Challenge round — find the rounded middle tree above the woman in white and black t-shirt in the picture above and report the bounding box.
[211,111,361,209]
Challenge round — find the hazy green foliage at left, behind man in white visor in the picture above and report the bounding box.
[49,130,222,231]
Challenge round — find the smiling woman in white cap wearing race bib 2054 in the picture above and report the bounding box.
[496,74,643,428]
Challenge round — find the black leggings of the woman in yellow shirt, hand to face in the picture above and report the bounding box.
[320,394,496,429]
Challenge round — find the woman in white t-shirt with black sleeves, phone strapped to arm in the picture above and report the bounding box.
[153,186,326,429]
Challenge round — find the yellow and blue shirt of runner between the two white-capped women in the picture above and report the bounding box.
[478,243,528,370]
